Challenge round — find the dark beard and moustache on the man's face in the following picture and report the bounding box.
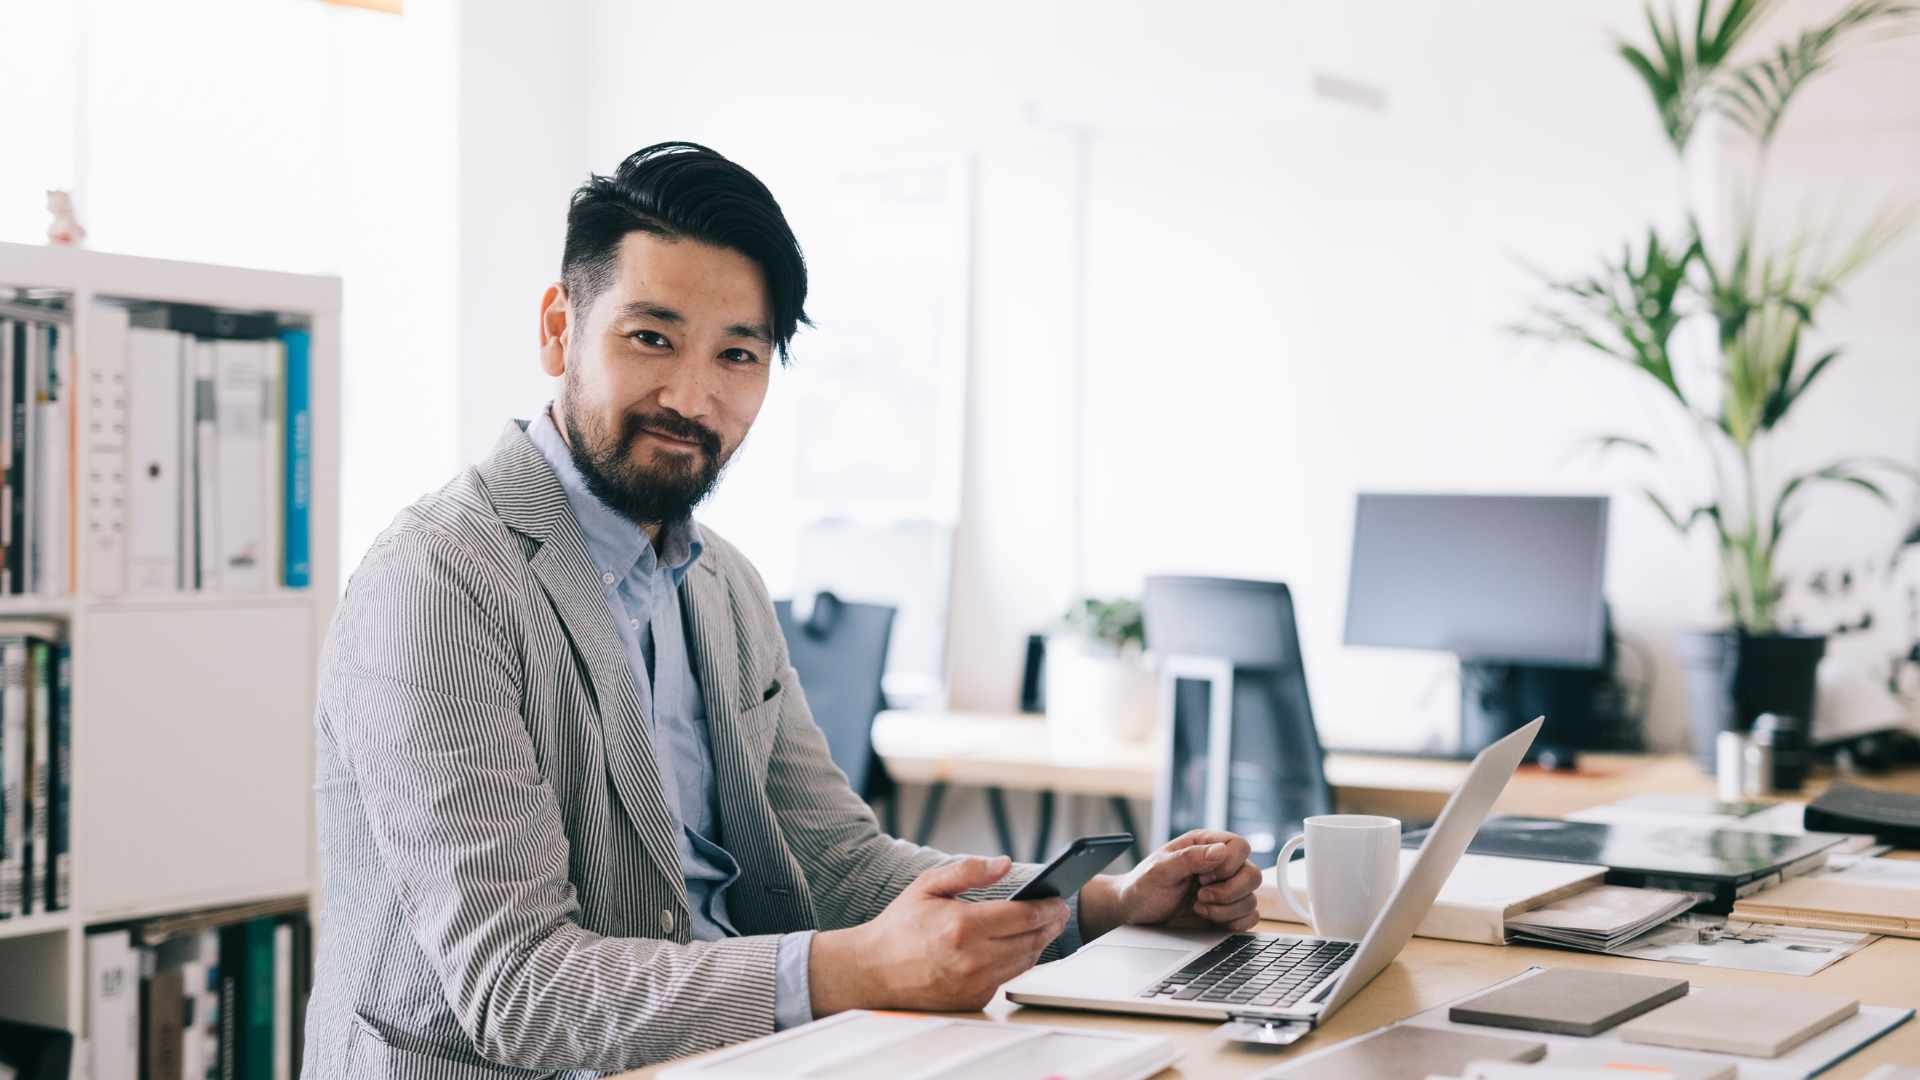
[561,379,732,525]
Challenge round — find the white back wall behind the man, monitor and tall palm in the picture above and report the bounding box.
[463,0,1920,757]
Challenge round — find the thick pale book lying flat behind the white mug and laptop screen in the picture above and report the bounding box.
[1256,849,1607,945]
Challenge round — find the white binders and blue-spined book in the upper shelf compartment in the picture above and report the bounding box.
[86,304,313,596]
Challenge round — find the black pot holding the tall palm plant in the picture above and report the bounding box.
[1680,630,1826,773]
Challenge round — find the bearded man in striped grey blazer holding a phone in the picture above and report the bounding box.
[305,142,1258,1080]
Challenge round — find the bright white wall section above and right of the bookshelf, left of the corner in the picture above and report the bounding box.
[0,0,459,569]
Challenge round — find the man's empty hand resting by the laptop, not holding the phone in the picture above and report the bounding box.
[1081,828,1260,940]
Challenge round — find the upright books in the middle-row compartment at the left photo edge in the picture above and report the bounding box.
[0,619,73,919]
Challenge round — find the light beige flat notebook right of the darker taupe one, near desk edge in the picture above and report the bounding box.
[1613,986,1860,1057]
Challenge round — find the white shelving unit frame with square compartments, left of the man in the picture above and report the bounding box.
[0,244,340,1036]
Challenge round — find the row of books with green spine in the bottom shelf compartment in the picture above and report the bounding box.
[86,897,311,1080]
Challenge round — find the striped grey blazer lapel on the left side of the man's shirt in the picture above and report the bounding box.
[480,423,687,911]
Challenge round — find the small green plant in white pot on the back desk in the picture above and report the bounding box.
[1046,598,1156,742]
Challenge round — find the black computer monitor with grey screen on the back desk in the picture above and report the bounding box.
[1344,492,1609,757]
